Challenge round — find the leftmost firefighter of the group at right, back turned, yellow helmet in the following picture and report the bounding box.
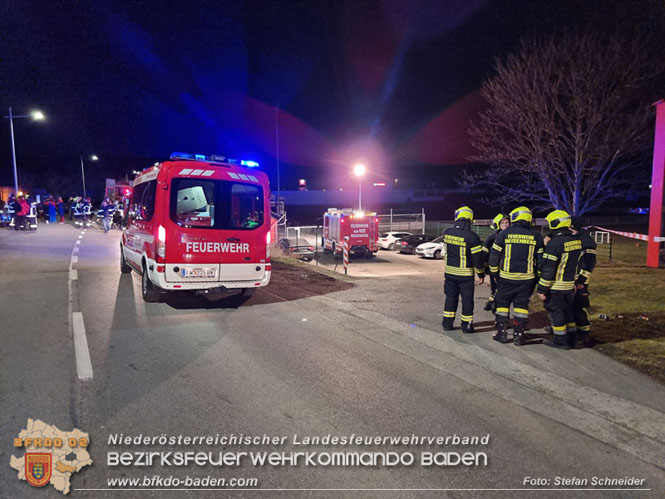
[442,206,485,333]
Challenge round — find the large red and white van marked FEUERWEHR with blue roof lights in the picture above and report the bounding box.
[120,153,272,301]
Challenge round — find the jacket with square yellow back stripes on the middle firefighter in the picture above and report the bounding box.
[489,220,543,281]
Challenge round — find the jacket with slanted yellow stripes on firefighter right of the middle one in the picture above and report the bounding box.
[538,228,582,294]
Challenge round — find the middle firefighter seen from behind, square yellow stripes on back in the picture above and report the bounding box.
[489,206,543,346]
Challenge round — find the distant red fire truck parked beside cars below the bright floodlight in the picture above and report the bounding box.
[322,208,379,258]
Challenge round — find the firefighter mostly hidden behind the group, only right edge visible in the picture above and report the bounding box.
[570,217,596,347]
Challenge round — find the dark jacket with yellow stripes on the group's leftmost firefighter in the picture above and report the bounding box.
[443,220,485,278]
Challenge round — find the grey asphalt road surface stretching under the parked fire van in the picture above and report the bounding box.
[0,225,665,498]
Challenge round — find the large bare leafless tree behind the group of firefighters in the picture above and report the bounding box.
[465,33,665,214]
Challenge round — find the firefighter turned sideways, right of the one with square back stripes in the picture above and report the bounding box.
[538,210,582,350]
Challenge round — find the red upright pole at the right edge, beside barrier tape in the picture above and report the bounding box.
[647,99,665,268]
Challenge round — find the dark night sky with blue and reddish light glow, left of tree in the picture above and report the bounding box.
[0,0,651,194]
